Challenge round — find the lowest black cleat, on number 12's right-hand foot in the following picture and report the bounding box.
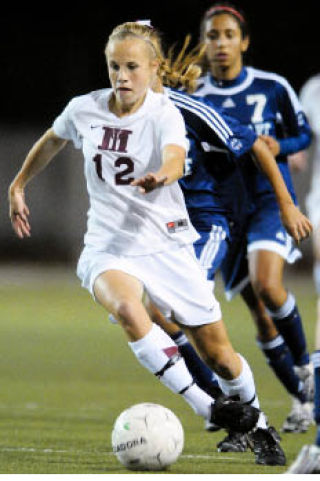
[248,426,286,466]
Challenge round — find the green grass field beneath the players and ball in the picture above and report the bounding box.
[0,264,315,474]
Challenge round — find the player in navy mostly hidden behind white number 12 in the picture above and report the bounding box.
[145,40,310,465]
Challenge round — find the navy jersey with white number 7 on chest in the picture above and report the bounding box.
[195,67,311,198]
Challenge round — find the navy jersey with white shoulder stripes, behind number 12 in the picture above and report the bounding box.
[169,90,257,229]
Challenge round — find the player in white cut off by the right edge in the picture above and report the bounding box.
[288,74,320,474]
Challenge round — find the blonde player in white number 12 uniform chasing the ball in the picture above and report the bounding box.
[9,19,310,454]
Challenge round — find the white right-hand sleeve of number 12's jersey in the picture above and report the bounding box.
[156,100,189,152]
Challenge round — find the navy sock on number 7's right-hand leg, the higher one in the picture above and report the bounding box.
[268,292,310,366]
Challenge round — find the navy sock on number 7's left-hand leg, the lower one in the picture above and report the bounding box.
[258,335,306,402]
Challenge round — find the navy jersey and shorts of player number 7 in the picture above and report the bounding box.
[195,67,311,298]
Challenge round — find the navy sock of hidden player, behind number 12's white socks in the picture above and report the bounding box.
[171,331,222,398]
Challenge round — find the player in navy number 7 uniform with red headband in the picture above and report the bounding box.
[196,2,313,442]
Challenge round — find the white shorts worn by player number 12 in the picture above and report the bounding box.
[77,245,222,326]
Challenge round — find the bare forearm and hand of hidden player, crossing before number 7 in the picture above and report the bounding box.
[252,139,312,242]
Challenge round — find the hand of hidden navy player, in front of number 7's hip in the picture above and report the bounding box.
[281,204,312,244]
